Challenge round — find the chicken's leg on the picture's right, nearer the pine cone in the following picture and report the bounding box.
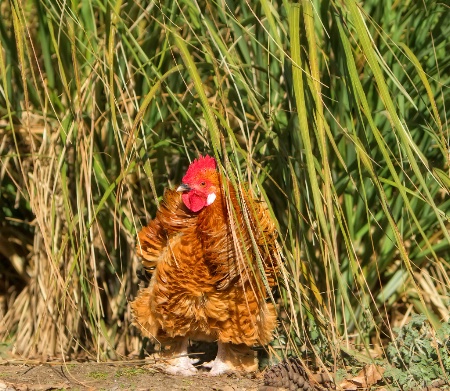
[208,341,258,376]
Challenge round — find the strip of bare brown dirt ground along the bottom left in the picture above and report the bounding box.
[0,362,263,391]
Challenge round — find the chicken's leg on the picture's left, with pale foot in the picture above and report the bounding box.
[161,337,197,376]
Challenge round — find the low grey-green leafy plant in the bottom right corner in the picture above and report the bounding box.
[384,314,450,390]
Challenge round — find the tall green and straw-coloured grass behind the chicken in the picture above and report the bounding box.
[0,0,450,382]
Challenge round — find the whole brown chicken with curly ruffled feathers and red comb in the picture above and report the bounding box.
[131,156,276,375]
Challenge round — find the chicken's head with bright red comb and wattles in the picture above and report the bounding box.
[177,155,220,212]
